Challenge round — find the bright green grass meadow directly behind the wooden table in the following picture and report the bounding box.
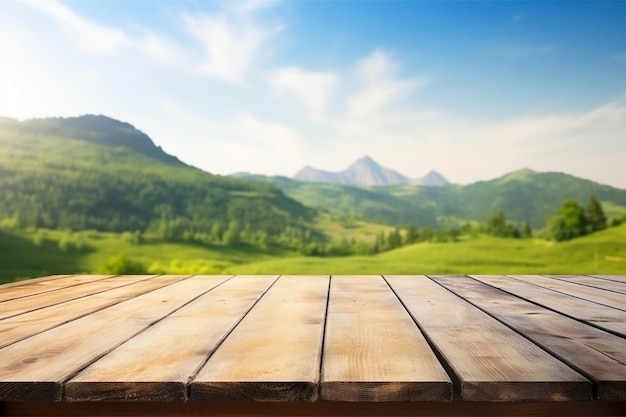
[0,219,626,282]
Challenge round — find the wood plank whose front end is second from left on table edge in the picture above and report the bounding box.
[64,276,277,401]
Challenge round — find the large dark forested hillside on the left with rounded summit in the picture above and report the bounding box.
[0,116,314,241]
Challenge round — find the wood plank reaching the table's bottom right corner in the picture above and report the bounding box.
[433,277,626,401]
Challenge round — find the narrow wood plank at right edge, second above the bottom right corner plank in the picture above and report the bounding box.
[508,275,626,311]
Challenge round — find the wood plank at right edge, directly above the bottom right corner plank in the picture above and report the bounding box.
[471,275,626,337]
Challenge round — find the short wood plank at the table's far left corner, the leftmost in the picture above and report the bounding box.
[0,275,113,300]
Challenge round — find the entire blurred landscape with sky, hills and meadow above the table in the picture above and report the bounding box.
[0,0,626,282]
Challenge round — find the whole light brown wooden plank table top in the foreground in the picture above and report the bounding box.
[0,275,626,411]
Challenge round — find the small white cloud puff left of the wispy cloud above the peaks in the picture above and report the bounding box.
[267,67,338,120]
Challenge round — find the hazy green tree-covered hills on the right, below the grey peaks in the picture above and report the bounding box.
[239,169,626,229]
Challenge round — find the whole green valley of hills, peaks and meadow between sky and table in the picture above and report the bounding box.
[0,115,626,283]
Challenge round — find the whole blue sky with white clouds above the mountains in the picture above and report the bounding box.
[0,0,626,188]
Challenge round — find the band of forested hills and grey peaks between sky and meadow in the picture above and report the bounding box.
[0,115,626,232]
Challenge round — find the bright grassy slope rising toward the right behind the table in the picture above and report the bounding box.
[225,221,626,275]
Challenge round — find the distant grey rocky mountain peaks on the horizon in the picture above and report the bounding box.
[293,155,449,187]
